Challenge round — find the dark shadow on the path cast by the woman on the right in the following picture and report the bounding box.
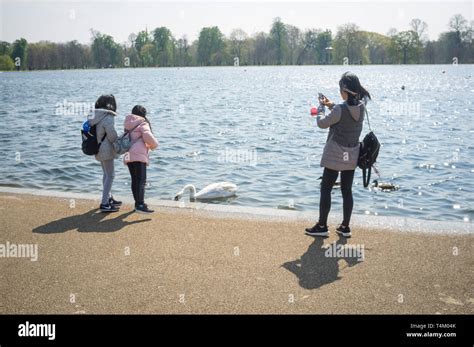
[282,237,359,289]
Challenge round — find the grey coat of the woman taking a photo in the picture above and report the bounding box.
[317,103,365,171]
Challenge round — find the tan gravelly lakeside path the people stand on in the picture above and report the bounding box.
[0,193,474,314]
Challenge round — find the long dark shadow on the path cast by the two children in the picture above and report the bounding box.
[33,209,151,234]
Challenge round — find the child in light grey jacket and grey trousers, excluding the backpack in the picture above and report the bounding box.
[89,95,122,212]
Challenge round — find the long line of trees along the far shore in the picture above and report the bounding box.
[0,14,474,70]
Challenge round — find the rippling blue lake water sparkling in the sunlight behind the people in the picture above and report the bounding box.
[0,65,474,223]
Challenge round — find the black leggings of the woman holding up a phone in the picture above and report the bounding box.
[319,168,355,226]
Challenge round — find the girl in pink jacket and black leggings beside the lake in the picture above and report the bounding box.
[123,105,158,213]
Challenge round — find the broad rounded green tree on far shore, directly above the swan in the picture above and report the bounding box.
[197,27,225,65]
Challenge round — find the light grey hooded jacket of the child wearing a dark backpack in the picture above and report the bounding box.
[89,109,118,161]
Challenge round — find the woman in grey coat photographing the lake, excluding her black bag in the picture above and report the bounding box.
[306,72,370,237]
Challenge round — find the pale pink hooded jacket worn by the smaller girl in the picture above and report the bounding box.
[123,114,158,165]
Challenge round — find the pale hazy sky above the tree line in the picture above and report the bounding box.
[0,0,474,43]
